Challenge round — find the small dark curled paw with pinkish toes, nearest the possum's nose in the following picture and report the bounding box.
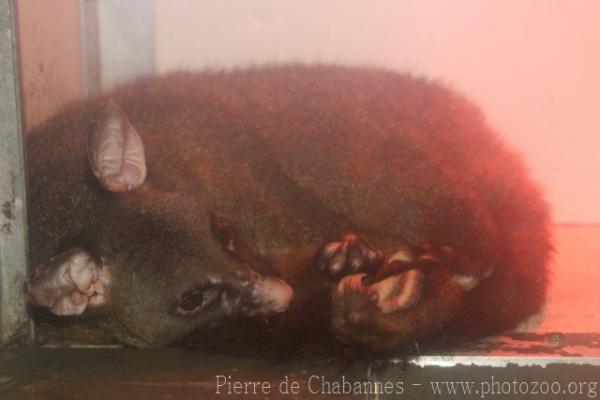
[316,233,383,278]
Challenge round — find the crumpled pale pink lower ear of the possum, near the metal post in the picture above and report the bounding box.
[26,248,108,316]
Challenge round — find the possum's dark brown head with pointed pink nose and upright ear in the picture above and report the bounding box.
[32,101,293,346]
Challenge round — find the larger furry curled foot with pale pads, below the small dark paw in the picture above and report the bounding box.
[331,245,492,351]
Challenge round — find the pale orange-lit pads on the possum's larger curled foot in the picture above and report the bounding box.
[336,269,424,314]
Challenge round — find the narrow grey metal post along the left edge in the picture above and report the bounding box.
[0,0,28,344]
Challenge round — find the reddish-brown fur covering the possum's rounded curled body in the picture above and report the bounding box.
[28,66,551,356]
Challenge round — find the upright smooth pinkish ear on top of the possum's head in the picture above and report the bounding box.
[87,100,146,192]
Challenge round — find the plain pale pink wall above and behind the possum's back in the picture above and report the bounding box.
[155,0,600,223]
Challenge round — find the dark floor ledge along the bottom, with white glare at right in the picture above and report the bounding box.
[0,349,600,400]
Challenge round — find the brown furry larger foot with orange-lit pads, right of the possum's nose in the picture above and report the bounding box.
[331,250,486,352]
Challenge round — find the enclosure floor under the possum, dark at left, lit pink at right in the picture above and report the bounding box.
[0,226,600,400]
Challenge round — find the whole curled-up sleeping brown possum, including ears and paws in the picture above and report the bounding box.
[26,65,551,351]
